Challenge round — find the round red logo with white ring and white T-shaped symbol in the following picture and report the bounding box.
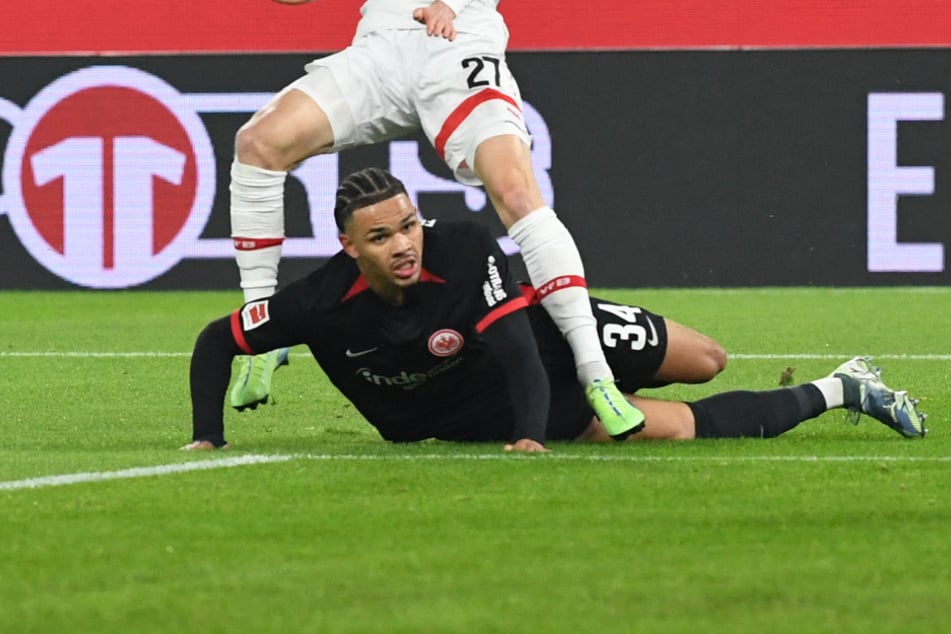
[3,66,215,288]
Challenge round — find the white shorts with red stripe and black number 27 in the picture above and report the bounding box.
[285,30,531,185]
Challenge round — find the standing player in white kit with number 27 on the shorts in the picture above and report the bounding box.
[230,0,644,439]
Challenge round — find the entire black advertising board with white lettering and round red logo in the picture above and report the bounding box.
[0,49,951,289]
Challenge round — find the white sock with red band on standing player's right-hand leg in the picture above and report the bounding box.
[509,207,614,385]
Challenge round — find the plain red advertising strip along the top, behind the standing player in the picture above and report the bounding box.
[0,0,951,55]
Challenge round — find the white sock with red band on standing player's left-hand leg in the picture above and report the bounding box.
[231,159,287,302]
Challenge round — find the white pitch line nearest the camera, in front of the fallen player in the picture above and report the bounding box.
[0,451,951,491]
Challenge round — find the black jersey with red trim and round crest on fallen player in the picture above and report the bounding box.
[225,220,544,441]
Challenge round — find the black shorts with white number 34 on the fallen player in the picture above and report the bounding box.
[529,298,667,440]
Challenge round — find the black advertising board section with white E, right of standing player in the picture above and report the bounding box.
[513,49,951,286]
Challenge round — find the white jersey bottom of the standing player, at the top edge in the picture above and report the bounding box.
[354,0,508,39]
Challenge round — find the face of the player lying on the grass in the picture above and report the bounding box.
[340,194,423,304]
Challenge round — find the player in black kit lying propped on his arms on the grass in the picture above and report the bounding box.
[184,168,925,452]
